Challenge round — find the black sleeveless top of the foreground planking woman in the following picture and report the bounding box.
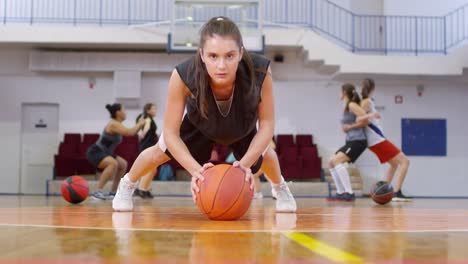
[176,54,270,145]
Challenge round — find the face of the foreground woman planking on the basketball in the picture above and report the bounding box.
[200,35,243,87]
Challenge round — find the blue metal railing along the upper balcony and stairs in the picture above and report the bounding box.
[0,0,468,55]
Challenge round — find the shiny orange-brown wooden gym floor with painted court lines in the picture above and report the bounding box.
[0,196,468,264]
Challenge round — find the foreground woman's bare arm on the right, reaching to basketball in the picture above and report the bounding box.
[239,68,275,168]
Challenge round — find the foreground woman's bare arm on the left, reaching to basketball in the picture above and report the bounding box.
[163,70,202,177]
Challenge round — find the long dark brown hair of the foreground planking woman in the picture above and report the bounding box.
[188,16,256,119]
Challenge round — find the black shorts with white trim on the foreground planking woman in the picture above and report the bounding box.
[158,116,263,173]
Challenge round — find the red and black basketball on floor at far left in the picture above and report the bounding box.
[62,175,89,204]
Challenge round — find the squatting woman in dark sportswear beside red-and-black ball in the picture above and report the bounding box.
[86,104,144,200]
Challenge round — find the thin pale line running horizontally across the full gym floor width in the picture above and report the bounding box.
[0,223,468,233]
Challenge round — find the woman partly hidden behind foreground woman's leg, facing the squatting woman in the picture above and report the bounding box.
[135,103,158,199]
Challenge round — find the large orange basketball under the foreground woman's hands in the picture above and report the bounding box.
[197,164,254,220]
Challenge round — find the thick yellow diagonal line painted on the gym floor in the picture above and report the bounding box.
[281,232,365,263]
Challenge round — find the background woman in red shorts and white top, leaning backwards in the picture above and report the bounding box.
[361,79,411,201]
